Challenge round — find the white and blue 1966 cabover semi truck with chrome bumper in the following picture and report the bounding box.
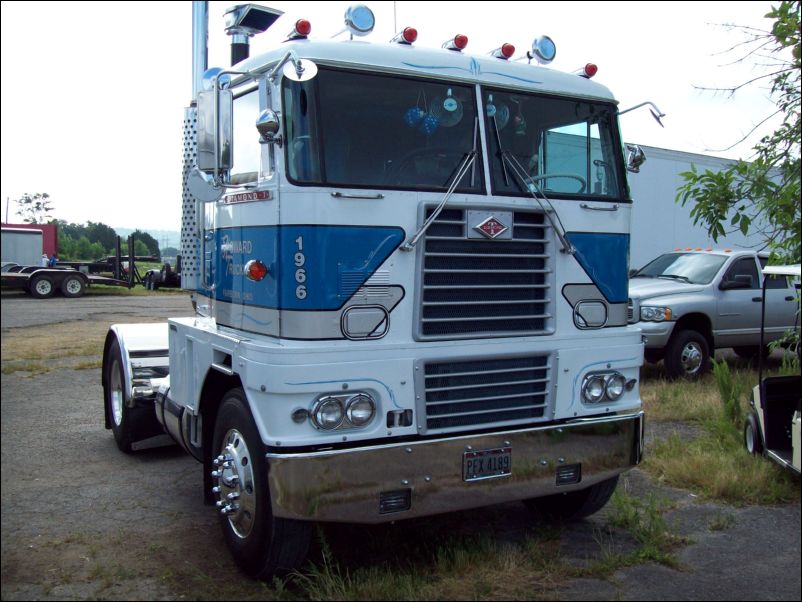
[103,5,643,578]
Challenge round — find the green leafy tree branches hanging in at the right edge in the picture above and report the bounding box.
[677,0,802,263]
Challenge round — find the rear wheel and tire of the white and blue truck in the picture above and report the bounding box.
[103,339,164,454]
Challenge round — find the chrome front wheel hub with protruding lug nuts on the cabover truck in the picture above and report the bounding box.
[212,429,256,538]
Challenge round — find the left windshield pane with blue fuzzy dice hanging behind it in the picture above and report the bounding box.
[283,69,484,192]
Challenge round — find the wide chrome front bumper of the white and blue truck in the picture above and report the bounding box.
[266,412,643,523]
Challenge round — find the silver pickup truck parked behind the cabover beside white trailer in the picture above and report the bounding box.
[629,250,799,378]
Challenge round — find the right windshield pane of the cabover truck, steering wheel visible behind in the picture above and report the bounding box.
[484,90,624,198]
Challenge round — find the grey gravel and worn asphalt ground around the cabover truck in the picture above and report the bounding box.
[0,295,801,600]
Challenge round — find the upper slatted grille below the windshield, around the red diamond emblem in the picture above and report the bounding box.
[418,209,551,339]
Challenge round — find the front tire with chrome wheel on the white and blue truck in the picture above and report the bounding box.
[212,388,312,580]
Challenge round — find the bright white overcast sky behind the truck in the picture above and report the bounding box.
[0,1,776,230]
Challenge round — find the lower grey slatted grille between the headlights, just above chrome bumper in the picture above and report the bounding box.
[424,356,550,432]
